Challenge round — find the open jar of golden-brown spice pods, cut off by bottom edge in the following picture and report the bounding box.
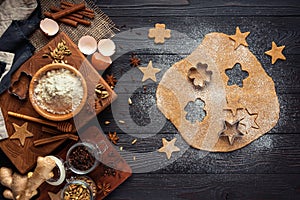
[61,180,94,200]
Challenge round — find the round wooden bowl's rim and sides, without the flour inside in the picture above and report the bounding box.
[29,63,87,121]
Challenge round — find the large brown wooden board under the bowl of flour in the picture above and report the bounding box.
[0,32,117,174]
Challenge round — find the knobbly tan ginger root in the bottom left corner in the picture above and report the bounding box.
[0,157,56,200]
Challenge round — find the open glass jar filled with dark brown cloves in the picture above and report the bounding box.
[67,142,99,174]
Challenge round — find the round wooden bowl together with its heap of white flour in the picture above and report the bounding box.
[29,63,87,121]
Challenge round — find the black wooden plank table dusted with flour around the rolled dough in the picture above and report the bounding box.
[0,0,300,200]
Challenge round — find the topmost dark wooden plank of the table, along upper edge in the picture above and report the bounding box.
[97,0,300,17]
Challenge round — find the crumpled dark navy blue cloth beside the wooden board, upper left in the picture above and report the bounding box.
[0,1,42,94]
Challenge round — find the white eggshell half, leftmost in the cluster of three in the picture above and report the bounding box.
[78,35,97,55]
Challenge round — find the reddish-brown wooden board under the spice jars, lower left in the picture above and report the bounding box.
[38,126,132,200]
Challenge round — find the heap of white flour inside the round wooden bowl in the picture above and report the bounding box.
[34,69,83,114]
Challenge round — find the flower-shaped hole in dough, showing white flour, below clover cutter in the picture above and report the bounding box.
[184,98,206,124]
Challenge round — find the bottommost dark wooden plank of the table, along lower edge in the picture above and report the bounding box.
[108,174,300,200]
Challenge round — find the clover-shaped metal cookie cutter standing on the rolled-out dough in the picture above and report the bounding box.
[188,63,212,88]
